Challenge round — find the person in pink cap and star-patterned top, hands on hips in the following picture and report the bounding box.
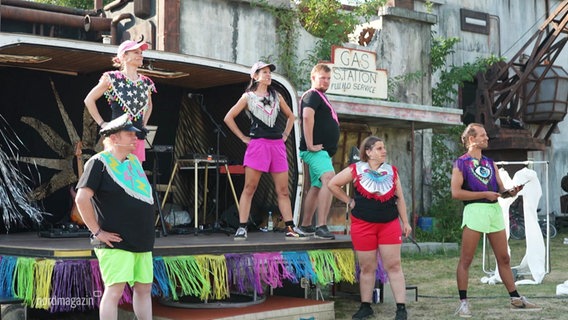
[84,40,156,162]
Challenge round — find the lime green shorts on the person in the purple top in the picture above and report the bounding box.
[462,203,505,233]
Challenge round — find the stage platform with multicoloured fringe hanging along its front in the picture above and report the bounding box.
[0,231,356,319]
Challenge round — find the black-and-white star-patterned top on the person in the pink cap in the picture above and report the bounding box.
[103,71,156,122]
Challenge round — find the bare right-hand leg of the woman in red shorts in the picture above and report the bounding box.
[379,244,406,303]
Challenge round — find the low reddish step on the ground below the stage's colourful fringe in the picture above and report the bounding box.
[119,296,335,320]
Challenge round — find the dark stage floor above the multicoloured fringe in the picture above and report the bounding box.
[0,231,352,259]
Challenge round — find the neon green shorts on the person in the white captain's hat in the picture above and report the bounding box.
[95,248,154,287]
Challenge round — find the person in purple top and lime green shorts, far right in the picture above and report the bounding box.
[451,123,541,318]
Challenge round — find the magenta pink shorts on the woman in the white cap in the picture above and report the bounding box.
[243,138,288,173]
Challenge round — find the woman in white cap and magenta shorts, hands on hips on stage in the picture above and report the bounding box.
[225,61,307,240]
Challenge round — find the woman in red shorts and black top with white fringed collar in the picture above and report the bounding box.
[328,136,412,320]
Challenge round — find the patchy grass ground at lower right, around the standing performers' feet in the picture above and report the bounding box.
[333,230,568,320]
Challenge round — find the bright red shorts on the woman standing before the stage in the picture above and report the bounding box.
[351,216,402,251]
